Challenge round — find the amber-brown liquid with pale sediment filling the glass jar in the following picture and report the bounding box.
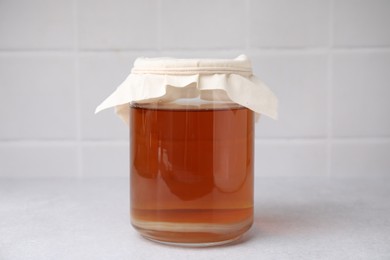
[130,106,254,245]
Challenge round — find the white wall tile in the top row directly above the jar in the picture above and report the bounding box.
[161,0,245,49]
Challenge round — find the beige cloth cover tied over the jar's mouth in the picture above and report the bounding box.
[95,55,278,122]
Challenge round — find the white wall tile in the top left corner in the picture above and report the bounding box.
[0,0,75,50]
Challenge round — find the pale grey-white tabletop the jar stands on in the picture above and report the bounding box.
[0,178,390,260]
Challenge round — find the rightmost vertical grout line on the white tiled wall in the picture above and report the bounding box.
[326,0,334,179]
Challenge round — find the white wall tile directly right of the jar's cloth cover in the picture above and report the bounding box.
[252,54,328,138]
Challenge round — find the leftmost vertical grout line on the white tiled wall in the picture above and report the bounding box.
[73,0,84,179]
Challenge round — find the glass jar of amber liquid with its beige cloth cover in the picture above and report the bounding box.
[96,55,277,246]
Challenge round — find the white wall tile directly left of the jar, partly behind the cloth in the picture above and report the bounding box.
[79,53,135,140]
